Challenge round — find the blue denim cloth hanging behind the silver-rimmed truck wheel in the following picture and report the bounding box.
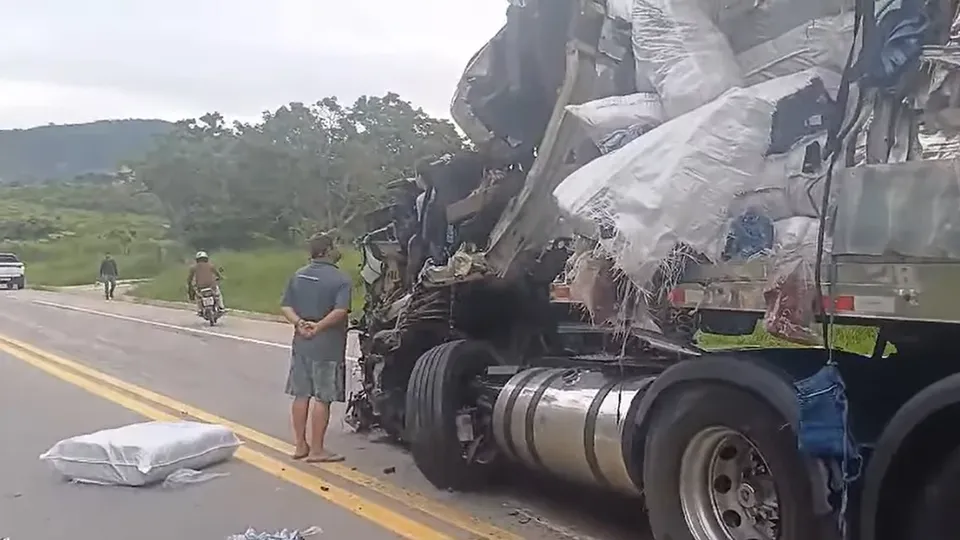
[794,362,863,538]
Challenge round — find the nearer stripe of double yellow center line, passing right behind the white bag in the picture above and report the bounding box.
[0,337,452,540]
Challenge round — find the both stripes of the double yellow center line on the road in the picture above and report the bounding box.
[0,335,523,540]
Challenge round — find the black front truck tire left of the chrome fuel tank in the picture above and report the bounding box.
[405,340,497,491]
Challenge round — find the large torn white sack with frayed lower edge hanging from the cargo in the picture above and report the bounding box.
[554,71,832,288]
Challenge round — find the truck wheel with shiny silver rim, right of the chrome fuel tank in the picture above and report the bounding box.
[643,383,825,540]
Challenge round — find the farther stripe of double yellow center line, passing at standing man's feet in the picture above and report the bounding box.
[0,335,523,540]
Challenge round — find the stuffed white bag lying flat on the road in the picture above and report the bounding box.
[40,422,241,486]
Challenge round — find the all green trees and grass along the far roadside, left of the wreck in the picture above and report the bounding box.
[0,93,452,306]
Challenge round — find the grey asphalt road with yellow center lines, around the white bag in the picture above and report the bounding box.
[0,290,649,540]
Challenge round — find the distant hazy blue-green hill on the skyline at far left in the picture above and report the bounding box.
[0,120,173,184]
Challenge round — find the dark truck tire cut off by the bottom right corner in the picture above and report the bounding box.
[905,449,960,540]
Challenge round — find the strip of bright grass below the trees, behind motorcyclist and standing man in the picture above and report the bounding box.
[129,248,363,314]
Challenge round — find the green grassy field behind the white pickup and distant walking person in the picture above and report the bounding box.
[0,188,182,286]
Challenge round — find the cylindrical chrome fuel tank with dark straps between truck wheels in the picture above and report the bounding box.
[493,368,656,495]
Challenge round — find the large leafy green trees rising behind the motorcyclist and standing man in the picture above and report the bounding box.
[131,93,463,249]
